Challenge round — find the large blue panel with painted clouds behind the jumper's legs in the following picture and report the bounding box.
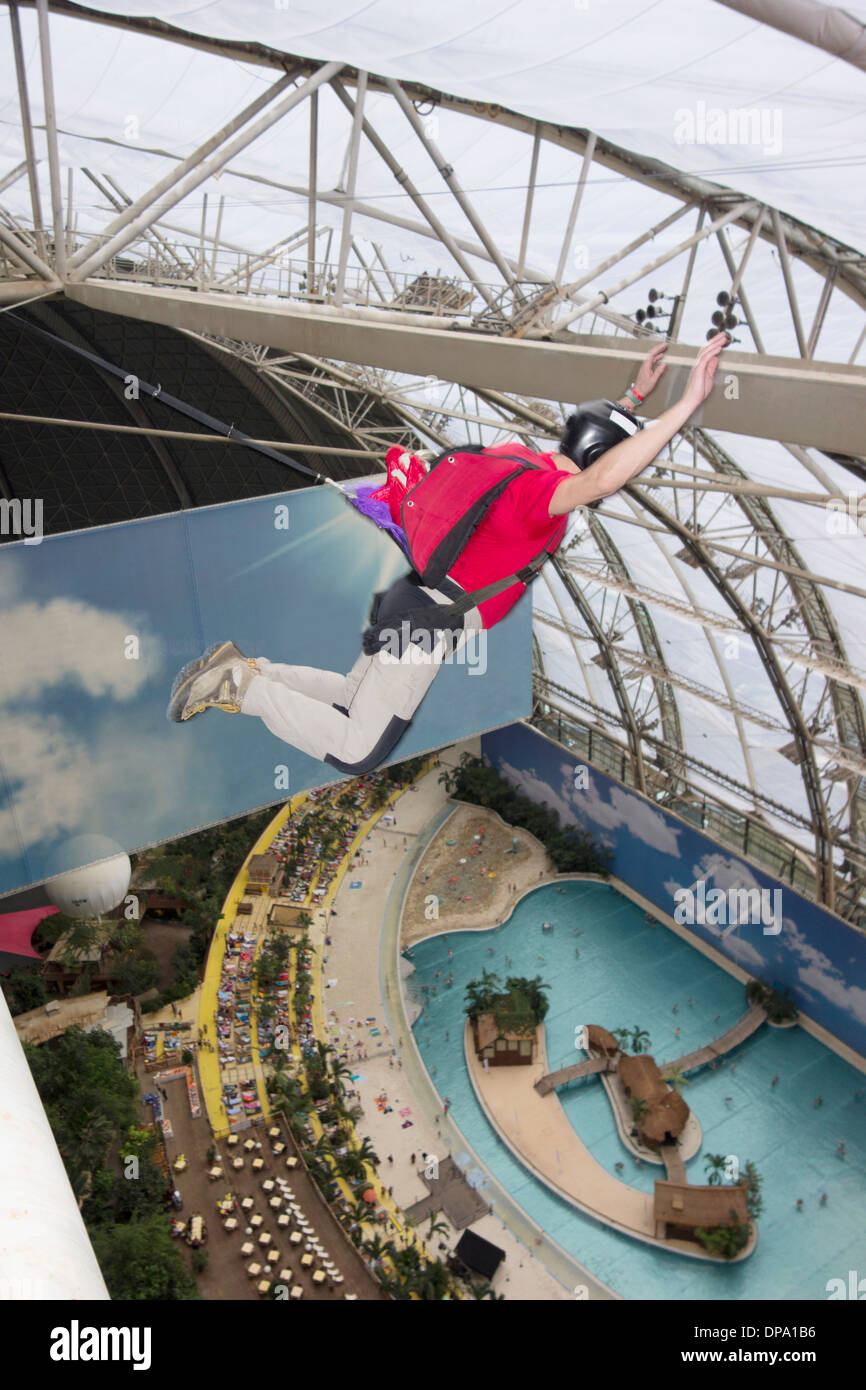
[0,488,531,892]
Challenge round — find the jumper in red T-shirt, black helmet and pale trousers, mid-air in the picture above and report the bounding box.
[167,332,730,776]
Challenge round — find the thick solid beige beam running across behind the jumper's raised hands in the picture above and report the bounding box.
[67,281,866,455]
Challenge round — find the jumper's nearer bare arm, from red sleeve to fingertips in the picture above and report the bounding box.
[549,332,730,517]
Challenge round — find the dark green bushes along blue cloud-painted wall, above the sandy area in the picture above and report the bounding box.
[439,753,610,877]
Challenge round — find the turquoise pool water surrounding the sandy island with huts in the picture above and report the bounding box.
[407,883,866,1300]
